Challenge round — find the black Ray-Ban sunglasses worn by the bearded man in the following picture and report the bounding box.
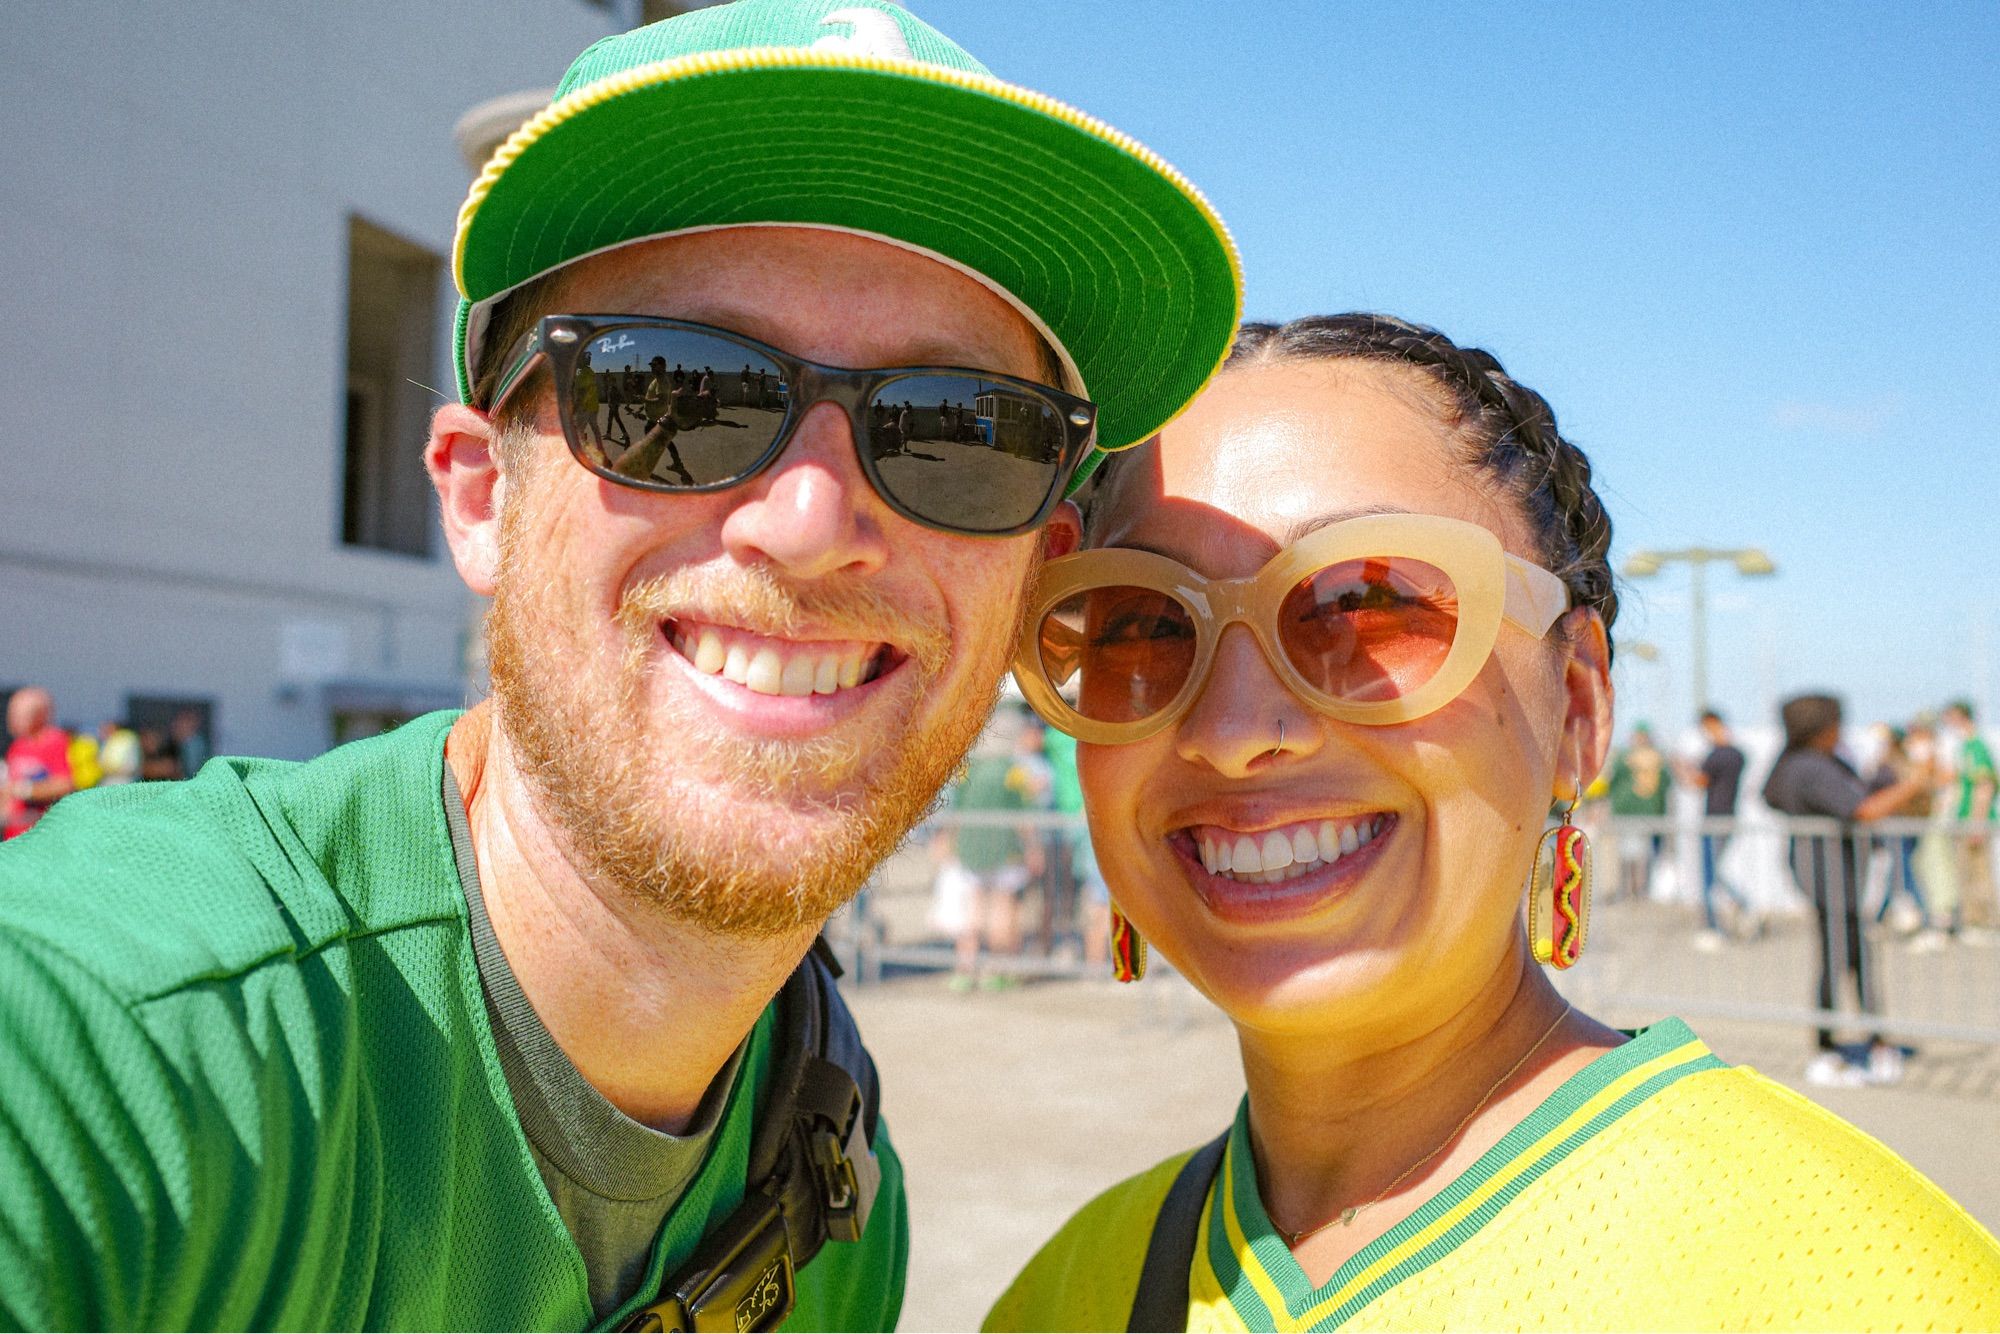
[488,314,1098,538]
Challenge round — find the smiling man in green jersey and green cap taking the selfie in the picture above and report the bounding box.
[0,0,1240,1330]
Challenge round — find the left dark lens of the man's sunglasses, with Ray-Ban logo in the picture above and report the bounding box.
[570,324,788,488]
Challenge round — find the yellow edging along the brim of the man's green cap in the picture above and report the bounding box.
[452,46,1244,444]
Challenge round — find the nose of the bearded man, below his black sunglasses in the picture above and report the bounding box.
[722,402,890,578]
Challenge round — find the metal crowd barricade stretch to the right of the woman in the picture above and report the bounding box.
[1558,810,2000,1044]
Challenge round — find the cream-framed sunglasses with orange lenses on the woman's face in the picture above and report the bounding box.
[1014,514,1570,744]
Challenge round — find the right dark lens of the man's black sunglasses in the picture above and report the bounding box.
[862,376,1064,532]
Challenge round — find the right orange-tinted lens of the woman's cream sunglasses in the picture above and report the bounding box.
[1278,556,1458,704]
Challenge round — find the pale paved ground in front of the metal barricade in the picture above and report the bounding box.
[848,976,2000,1330]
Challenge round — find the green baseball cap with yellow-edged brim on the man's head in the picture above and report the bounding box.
[452,0,1242,480]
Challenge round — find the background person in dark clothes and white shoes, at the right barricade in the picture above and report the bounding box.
[1764,694,1924,1086]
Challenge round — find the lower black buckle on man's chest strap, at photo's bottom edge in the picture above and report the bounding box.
[620,1196,798,1334]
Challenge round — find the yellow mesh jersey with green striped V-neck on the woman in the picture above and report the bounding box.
[986,1020,2000,1330]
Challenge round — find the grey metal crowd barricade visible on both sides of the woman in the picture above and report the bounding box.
[828,808,2000,1046]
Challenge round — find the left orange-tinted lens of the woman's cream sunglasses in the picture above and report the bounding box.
[1038,586,1194,722]
